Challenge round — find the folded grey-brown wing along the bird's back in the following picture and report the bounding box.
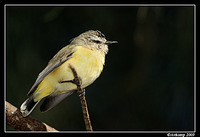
[27,45,74,96]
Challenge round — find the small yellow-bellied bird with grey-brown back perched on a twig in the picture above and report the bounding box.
[20,30,117,117]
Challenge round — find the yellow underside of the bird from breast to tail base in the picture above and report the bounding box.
[34,46,105,101]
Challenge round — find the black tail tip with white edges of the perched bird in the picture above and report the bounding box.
[20,96,40,117]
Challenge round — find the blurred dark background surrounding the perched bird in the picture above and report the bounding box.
[6,6,194,131]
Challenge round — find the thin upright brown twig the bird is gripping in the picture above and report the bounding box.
[69,64,93,131]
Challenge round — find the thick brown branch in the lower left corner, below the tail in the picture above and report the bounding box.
[5,101,59,132]
